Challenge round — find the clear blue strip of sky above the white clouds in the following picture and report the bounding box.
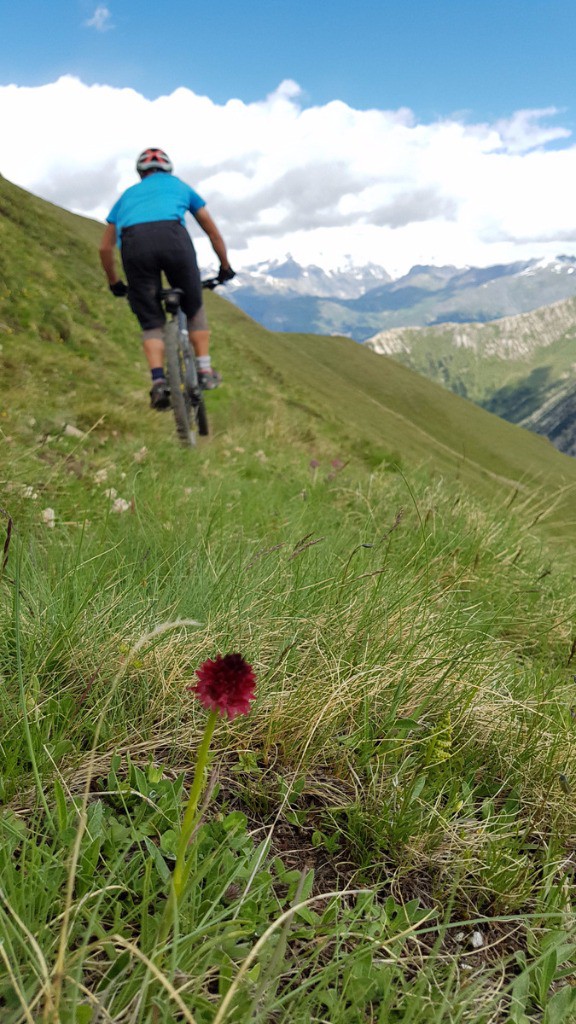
[0,0,576,123]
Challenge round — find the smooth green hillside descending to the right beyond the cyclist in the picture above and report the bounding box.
[210,302,576,538]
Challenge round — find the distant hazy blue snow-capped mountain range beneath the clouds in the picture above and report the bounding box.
[228,256,576,341]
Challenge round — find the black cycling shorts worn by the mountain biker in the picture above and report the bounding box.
[121,220,202,331]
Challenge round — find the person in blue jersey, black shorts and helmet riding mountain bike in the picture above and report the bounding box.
[99,148,235,410]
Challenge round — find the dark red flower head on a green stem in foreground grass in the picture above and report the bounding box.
[188,654,256,719]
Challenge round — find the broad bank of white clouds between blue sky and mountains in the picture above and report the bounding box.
[0,74,576,273]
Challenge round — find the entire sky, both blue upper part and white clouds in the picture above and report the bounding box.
[0,0,576,273]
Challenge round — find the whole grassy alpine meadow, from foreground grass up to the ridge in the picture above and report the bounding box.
[0,178,576,1024]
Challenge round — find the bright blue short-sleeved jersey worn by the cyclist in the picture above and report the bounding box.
[106,171,206,245]
